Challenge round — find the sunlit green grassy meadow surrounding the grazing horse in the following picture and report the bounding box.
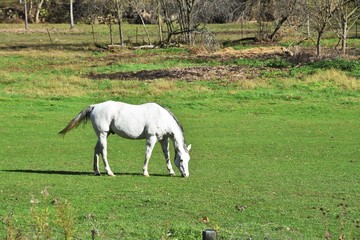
[0,25,360,239]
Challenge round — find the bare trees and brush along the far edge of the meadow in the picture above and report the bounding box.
[0,0,360,55]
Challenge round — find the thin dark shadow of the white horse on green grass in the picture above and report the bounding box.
[1,169,174,177]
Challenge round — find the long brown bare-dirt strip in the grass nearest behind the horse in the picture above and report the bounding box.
[89,66,245,81]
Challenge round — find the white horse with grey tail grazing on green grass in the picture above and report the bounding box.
[59,101,191,177]
